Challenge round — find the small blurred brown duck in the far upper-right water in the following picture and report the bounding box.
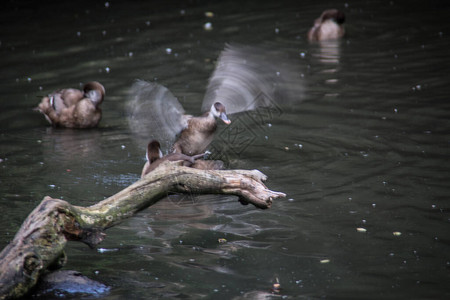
[308,9,345,42]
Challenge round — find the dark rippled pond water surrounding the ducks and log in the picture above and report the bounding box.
[0,0,450,299]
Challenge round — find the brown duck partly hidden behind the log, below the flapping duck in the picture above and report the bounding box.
[141,140,205,178]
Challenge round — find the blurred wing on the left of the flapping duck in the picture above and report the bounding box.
[127,80,187,149]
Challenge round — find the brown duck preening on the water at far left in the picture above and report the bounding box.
[35,81,105,128]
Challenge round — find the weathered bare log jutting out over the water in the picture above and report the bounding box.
[0,162,285,299]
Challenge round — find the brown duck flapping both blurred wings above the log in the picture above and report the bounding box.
[127,45,300,169]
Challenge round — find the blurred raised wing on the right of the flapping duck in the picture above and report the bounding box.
[202,45,298,114]
